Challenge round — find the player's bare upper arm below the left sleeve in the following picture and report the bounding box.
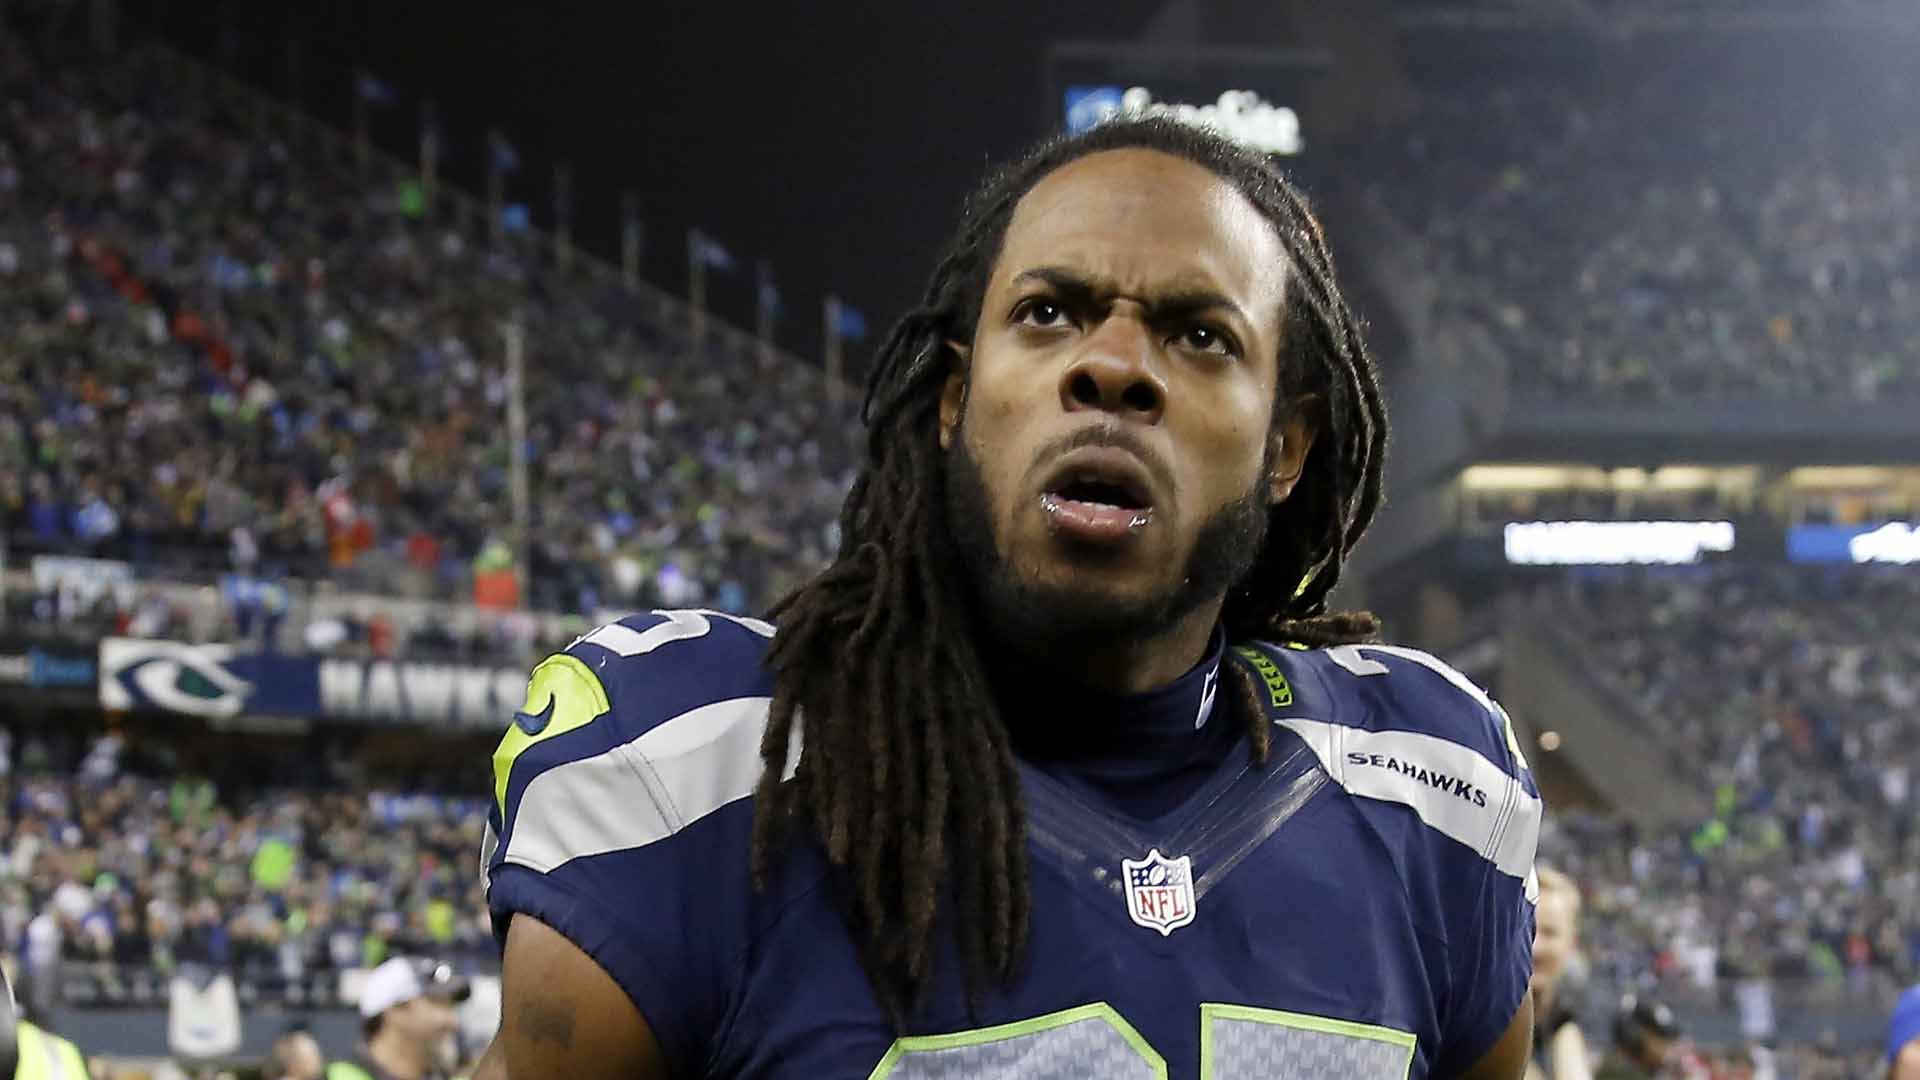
[491,915,666,1080]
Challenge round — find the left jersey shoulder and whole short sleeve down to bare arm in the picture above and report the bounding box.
[482,611,799,1061]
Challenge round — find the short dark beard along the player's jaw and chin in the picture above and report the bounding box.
[945,421,1271,644]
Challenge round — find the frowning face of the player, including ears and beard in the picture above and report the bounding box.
[941,150,1311,638]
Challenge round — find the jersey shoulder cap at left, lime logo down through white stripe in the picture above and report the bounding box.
[486,611,774,872]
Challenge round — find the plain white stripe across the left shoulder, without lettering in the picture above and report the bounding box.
[503,698,799,872]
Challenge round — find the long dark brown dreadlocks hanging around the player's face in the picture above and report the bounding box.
[753,119,1386,1024]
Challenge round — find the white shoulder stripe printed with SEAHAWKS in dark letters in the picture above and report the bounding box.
[1275,717,1540,880]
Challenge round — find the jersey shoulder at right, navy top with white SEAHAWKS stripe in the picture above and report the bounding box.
[1238,642,1542,894]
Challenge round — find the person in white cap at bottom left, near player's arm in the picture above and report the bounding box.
[326,957,468,1080]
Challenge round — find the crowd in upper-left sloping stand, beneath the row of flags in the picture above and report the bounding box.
[0,37,854,611]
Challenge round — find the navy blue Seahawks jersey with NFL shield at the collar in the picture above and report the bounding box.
[484,611,1540,1080]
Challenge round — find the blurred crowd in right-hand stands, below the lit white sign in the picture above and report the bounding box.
[1536,567,1920,1009]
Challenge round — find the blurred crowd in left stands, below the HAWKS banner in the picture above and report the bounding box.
[0,722,495,1015]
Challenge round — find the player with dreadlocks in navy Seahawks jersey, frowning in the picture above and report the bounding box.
[482,119,1540,1080]
